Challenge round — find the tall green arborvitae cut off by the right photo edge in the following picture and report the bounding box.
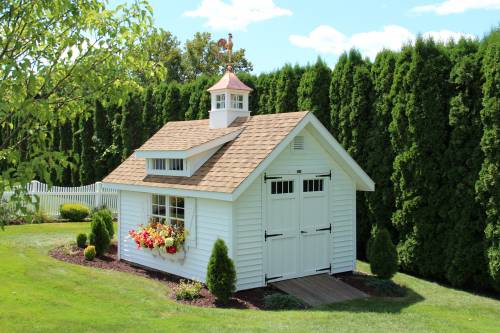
[476,29,500,290]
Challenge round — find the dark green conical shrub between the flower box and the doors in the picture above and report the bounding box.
[207,239,236,303]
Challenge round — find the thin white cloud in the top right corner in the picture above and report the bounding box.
[412,0,500,15]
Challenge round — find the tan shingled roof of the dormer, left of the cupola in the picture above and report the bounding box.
[137,119,241,151]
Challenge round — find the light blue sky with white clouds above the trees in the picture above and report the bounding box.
[110,0,500,74]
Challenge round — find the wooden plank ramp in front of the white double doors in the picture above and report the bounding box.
[271,274,368,306]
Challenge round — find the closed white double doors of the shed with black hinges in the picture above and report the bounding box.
[264,174,331,281]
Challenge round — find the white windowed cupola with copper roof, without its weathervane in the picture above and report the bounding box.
[208,66,252,128]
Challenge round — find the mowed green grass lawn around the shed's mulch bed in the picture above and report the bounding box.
[0,223,500,333]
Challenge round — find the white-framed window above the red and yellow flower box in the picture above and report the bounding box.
[151,194,184,227]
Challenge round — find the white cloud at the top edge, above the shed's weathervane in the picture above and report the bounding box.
[184,0,292,31]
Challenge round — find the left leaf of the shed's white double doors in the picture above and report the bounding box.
[264,176,300,280]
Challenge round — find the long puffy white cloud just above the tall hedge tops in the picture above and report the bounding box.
[289,25,474,59]
